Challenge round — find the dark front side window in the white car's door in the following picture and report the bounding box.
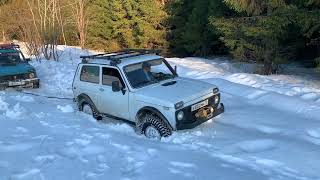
[102,67,125,88]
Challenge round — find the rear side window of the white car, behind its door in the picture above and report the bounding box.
[80,66,100,84]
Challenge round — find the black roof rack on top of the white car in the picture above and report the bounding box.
[80,49,161,66]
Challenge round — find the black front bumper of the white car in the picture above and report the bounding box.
[176,103,224,130]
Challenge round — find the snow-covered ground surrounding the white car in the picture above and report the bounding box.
[0,46,320,180]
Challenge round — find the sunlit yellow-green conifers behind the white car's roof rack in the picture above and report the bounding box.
[88,0,166,51]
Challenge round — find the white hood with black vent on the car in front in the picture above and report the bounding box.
[135,77,216,107]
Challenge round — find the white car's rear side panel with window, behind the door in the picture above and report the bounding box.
[73,65,100,106]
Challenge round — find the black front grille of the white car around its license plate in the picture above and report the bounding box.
[176,94,220,124]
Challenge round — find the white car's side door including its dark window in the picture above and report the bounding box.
[99,67,129,120]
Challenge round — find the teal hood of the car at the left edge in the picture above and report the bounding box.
[0,63,35,76]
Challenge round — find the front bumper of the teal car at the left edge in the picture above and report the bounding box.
[0,78,40,89]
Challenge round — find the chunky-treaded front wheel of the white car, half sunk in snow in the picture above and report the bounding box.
[142,114,172,140]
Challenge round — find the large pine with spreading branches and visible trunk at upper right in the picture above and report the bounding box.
[211,0,320,74]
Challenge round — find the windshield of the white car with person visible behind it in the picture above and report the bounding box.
[124,59,175,88]
